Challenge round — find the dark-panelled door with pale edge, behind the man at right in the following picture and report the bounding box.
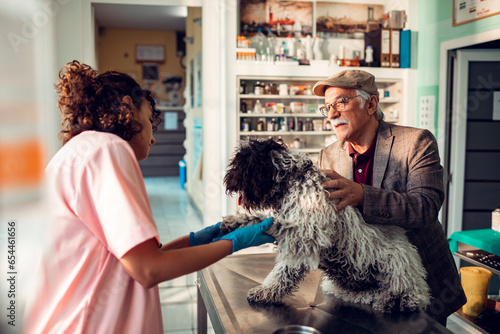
[447,49,500,234]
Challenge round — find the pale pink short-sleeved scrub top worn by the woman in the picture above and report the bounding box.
[23,131,163,334]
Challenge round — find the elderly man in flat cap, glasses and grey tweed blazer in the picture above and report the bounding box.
[313,70,466,325]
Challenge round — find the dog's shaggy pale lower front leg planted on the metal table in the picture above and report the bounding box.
[247,262,309,304]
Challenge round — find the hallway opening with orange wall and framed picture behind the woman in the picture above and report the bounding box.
[93,3,188,177]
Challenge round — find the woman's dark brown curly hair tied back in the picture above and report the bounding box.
[55,60,161,145]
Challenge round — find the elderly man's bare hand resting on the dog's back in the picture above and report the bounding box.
[321,169,365,210]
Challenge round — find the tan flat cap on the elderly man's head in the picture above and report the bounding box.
[313,70,379,99]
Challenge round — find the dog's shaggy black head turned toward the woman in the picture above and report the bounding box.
[224,139,313,211]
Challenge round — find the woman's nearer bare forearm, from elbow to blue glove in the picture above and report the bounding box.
[120,236,233,289]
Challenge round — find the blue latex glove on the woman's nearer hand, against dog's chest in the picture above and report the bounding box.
[214,218,274,253]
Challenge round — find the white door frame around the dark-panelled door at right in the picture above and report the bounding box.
[437,29,500,236]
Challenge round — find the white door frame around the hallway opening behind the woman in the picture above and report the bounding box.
[79,0,234,225]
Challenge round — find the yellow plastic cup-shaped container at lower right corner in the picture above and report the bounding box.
[460,267,492,317]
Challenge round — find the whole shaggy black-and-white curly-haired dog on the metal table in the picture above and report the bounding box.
[221,139,430,312]
